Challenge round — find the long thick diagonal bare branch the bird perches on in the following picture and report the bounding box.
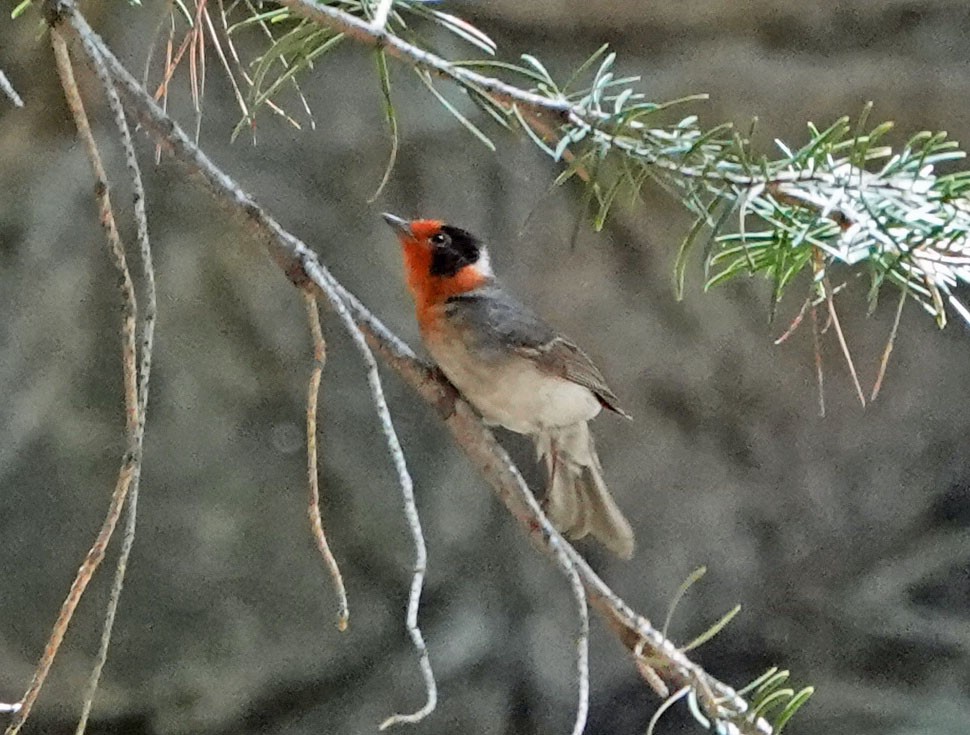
[51,0,771,734]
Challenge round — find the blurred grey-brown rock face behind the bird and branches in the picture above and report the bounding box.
[0,0,970,735]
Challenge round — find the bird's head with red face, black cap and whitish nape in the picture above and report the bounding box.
[384,214,492,319]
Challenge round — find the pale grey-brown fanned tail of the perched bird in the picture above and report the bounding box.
[536,421,633,559]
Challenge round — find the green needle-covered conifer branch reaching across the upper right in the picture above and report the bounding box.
[246,0,970,327]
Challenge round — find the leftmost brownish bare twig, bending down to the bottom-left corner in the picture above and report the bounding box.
[6,28,139,735]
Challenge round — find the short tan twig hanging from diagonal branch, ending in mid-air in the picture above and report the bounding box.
[303,291,350,631]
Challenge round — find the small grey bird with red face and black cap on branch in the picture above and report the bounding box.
[382,213,634,559]
